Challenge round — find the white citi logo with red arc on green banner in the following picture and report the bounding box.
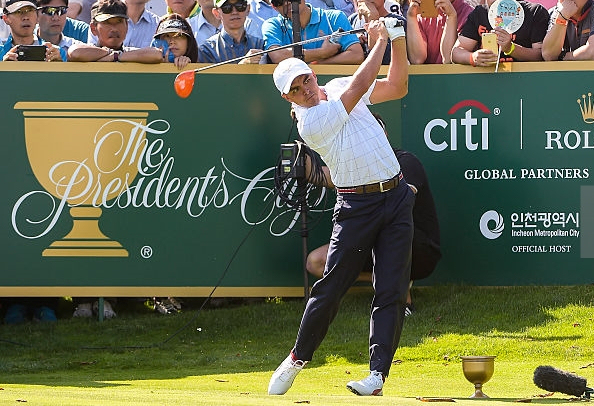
[423,100,492,152]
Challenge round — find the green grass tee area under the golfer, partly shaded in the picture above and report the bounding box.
[0,286,594,406]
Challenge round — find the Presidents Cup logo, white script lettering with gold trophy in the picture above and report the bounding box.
[11,102,327,257]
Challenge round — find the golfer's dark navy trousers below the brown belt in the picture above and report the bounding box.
[293,180,415,376]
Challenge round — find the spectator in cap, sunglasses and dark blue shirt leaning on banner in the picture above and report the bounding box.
[198,0,264,64]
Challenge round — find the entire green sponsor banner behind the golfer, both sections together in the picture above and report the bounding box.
[0,62,594,296]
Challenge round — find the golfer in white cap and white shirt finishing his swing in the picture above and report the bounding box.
[268,19,414,396]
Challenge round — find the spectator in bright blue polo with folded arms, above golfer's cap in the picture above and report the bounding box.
[262,0,364,65]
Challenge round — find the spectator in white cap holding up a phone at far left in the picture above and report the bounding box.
[0,0,62,62]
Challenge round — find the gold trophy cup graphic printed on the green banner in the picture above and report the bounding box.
[14,102,158,257]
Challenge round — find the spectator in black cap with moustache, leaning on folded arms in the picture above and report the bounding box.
[68,0,163,63]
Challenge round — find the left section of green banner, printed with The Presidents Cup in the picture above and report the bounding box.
[0,64,346,296]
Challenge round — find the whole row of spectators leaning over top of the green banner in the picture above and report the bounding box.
[0,0,580,64]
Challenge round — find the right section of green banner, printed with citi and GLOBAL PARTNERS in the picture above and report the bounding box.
[403,63,594,285]
